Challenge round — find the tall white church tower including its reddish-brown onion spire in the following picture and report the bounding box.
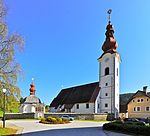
[98,9,121,118]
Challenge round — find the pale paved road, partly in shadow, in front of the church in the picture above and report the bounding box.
[2,120,131,136]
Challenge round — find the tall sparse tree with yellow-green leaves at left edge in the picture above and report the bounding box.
[0,0,24,111]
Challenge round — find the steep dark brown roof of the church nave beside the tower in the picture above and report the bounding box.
[50,82,100,107]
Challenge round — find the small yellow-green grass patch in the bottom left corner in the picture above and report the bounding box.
[0,126,17,136]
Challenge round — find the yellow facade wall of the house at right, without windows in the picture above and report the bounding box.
[128,96,150,118]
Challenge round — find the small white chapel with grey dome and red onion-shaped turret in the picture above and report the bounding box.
[20,80,45,118]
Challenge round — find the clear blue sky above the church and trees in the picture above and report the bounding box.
[5,0,150,104]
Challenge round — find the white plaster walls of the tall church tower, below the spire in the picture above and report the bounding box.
[99,53,120,117]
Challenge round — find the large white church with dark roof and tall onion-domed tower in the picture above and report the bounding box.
[50,10,121,118]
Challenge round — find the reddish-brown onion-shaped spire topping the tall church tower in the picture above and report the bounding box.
[102,9,118,53]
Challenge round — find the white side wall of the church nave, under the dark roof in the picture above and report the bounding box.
[71,103,95,113]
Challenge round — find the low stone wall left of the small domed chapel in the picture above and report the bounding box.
[5,113,35,119]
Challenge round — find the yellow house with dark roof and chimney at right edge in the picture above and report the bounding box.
[127,86,150,118]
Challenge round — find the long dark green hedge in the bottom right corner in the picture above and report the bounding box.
[103,122,150,136]
